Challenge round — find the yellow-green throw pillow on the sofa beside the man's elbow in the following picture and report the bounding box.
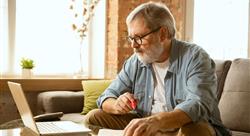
[81,80,112,115]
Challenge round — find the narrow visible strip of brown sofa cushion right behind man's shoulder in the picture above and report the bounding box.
[214,60,232,100]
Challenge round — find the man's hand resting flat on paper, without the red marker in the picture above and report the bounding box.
[124,116,159,136]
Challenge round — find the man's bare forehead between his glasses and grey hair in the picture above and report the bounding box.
[128,18,149,36]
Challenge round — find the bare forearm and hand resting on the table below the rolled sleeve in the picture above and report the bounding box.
[124,109,192,136]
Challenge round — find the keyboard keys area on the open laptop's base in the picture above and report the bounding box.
[36,122,65,133]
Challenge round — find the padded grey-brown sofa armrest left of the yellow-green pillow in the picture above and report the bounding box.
[37,91,84,114]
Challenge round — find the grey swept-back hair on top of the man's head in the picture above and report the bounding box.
[126,2,176,38]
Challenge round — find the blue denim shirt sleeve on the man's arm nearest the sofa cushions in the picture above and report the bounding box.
[175,49,218,122]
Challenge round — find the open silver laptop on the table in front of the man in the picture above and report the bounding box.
[8,82,91,136]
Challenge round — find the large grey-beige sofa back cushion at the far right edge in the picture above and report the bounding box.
[219,59,250,132]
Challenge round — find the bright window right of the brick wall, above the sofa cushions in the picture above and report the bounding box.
[187,0,249,59]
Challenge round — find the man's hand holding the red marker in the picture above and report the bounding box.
[102,92,136,114]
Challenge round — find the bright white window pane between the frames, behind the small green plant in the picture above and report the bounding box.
[15,0,88,74]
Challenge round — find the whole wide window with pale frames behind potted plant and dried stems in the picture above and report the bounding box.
[0,0,106,78]
